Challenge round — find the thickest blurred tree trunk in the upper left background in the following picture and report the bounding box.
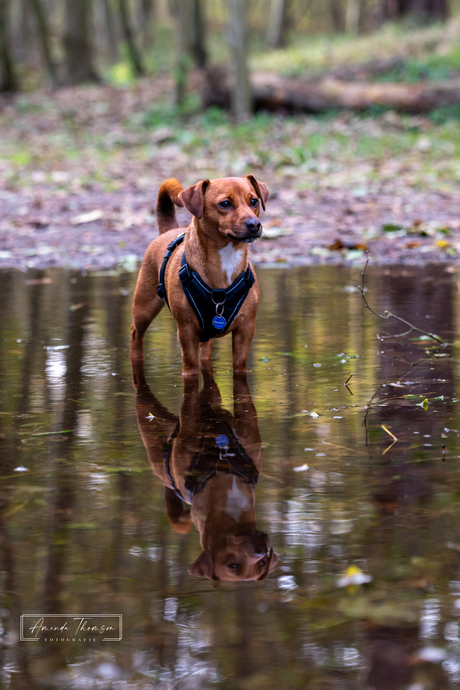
[64,0,99,84]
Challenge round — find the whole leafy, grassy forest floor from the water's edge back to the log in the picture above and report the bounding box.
[0,78,460,270]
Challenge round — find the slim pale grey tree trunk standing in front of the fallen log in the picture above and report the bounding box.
[227,0,252,122]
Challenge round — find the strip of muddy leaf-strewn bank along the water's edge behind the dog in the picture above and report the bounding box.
[0,184,460,270]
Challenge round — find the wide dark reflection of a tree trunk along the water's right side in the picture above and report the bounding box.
[366,268,457,690]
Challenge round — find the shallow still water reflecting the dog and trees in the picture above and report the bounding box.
[0,260,460,690]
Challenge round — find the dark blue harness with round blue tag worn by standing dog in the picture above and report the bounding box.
[157,233,255,343]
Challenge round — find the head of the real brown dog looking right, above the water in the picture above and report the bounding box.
[179,175,269,243]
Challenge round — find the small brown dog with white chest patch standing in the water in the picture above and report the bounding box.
[131,175,269,376]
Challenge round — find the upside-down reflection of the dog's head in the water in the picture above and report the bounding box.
[189,530,278,581]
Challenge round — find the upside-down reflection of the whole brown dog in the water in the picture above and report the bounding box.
[133,363,278,580]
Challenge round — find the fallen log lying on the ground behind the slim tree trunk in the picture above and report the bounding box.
[203,67,460,113]
